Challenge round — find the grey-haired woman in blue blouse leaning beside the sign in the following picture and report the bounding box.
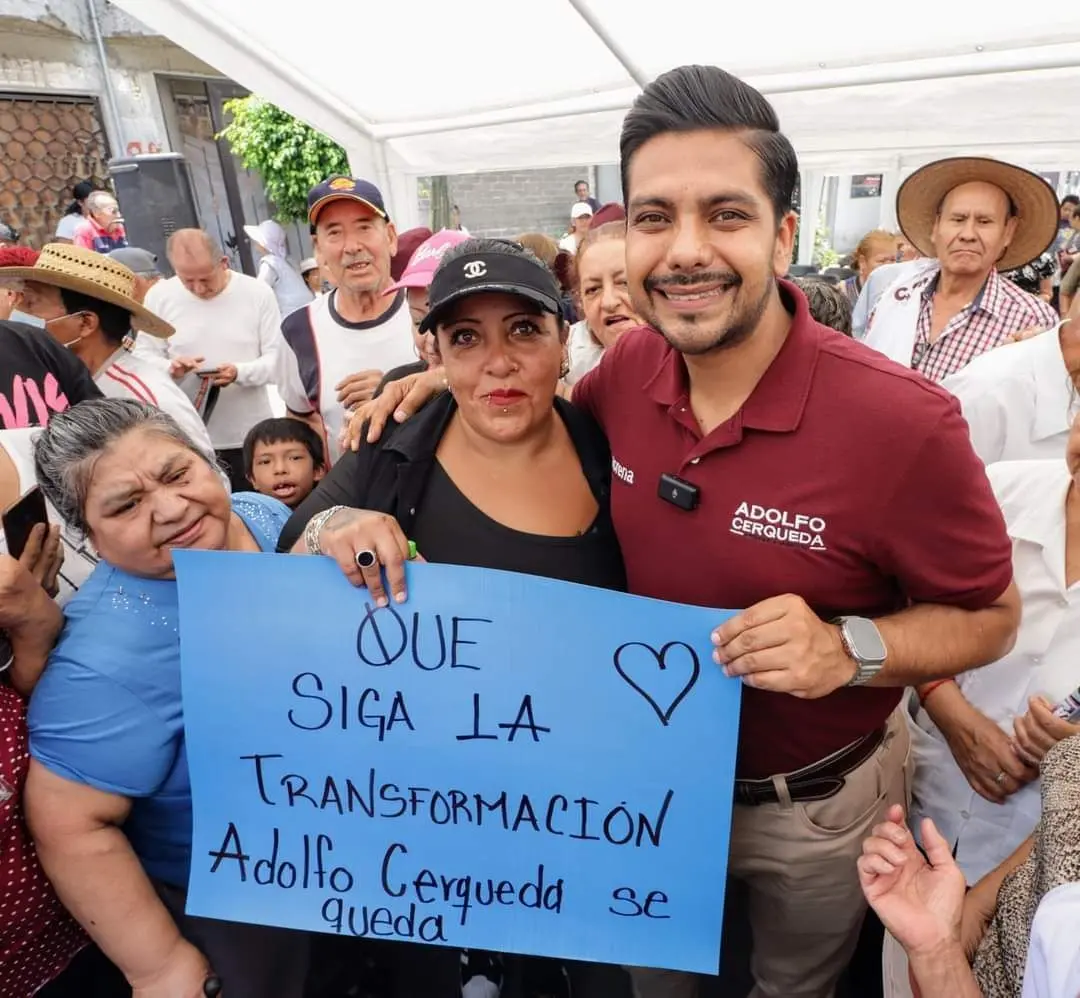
[26,399,308,998]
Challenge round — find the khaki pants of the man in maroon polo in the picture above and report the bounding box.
[631,710,910,998]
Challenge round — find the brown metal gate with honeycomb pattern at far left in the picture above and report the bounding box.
[0,93,109,248]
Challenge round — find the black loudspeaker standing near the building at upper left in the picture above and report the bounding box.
[109,152,199,278]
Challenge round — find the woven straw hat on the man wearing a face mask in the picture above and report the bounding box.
[0,243,175,339]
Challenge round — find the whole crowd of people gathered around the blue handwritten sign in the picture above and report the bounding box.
[0,58,1080,998]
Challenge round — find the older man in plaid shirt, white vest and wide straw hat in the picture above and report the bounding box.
[864,157,1058,381]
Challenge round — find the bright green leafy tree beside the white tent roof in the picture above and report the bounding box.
[218,94,349,221]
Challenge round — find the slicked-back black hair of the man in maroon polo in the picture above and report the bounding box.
[619,66,799,222]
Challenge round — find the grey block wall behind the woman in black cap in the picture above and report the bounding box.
[449,166,589,238]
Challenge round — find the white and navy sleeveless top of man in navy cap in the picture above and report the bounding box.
[279,292,416,461]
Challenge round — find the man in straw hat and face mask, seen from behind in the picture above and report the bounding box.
[0,244,211,448]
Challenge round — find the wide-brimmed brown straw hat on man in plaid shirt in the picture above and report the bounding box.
[896,156,1059,270]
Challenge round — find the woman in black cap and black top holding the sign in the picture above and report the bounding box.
[279,239,630,998]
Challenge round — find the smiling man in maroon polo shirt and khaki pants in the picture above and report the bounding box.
[573,67,1020,998]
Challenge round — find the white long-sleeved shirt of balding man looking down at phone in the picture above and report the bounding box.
[135,272,282,450]
